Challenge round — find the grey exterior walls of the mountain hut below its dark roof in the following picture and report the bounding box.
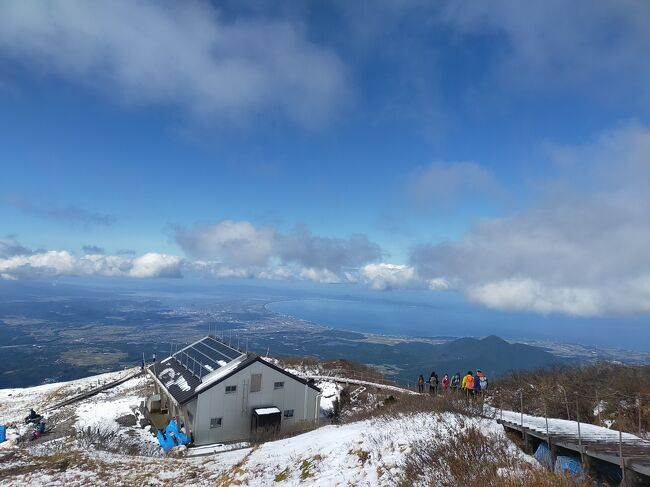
[193,362,320,445]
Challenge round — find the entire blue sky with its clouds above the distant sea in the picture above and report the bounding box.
[0,0,650,316]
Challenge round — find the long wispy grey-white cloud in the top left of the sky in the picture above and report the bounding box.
[0,0,346,124]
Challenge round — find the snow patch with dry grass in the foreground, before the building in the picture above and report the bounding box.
[0,413,523,487]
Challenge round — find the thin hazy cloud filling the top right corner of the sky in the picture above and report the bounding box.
[440,0,650,106]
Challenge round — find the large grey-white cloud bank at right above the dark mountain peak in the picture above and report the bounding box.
[411,125,650,316]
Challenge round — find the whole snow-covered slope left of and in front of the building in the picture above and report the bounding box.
[0,373,536,486]
